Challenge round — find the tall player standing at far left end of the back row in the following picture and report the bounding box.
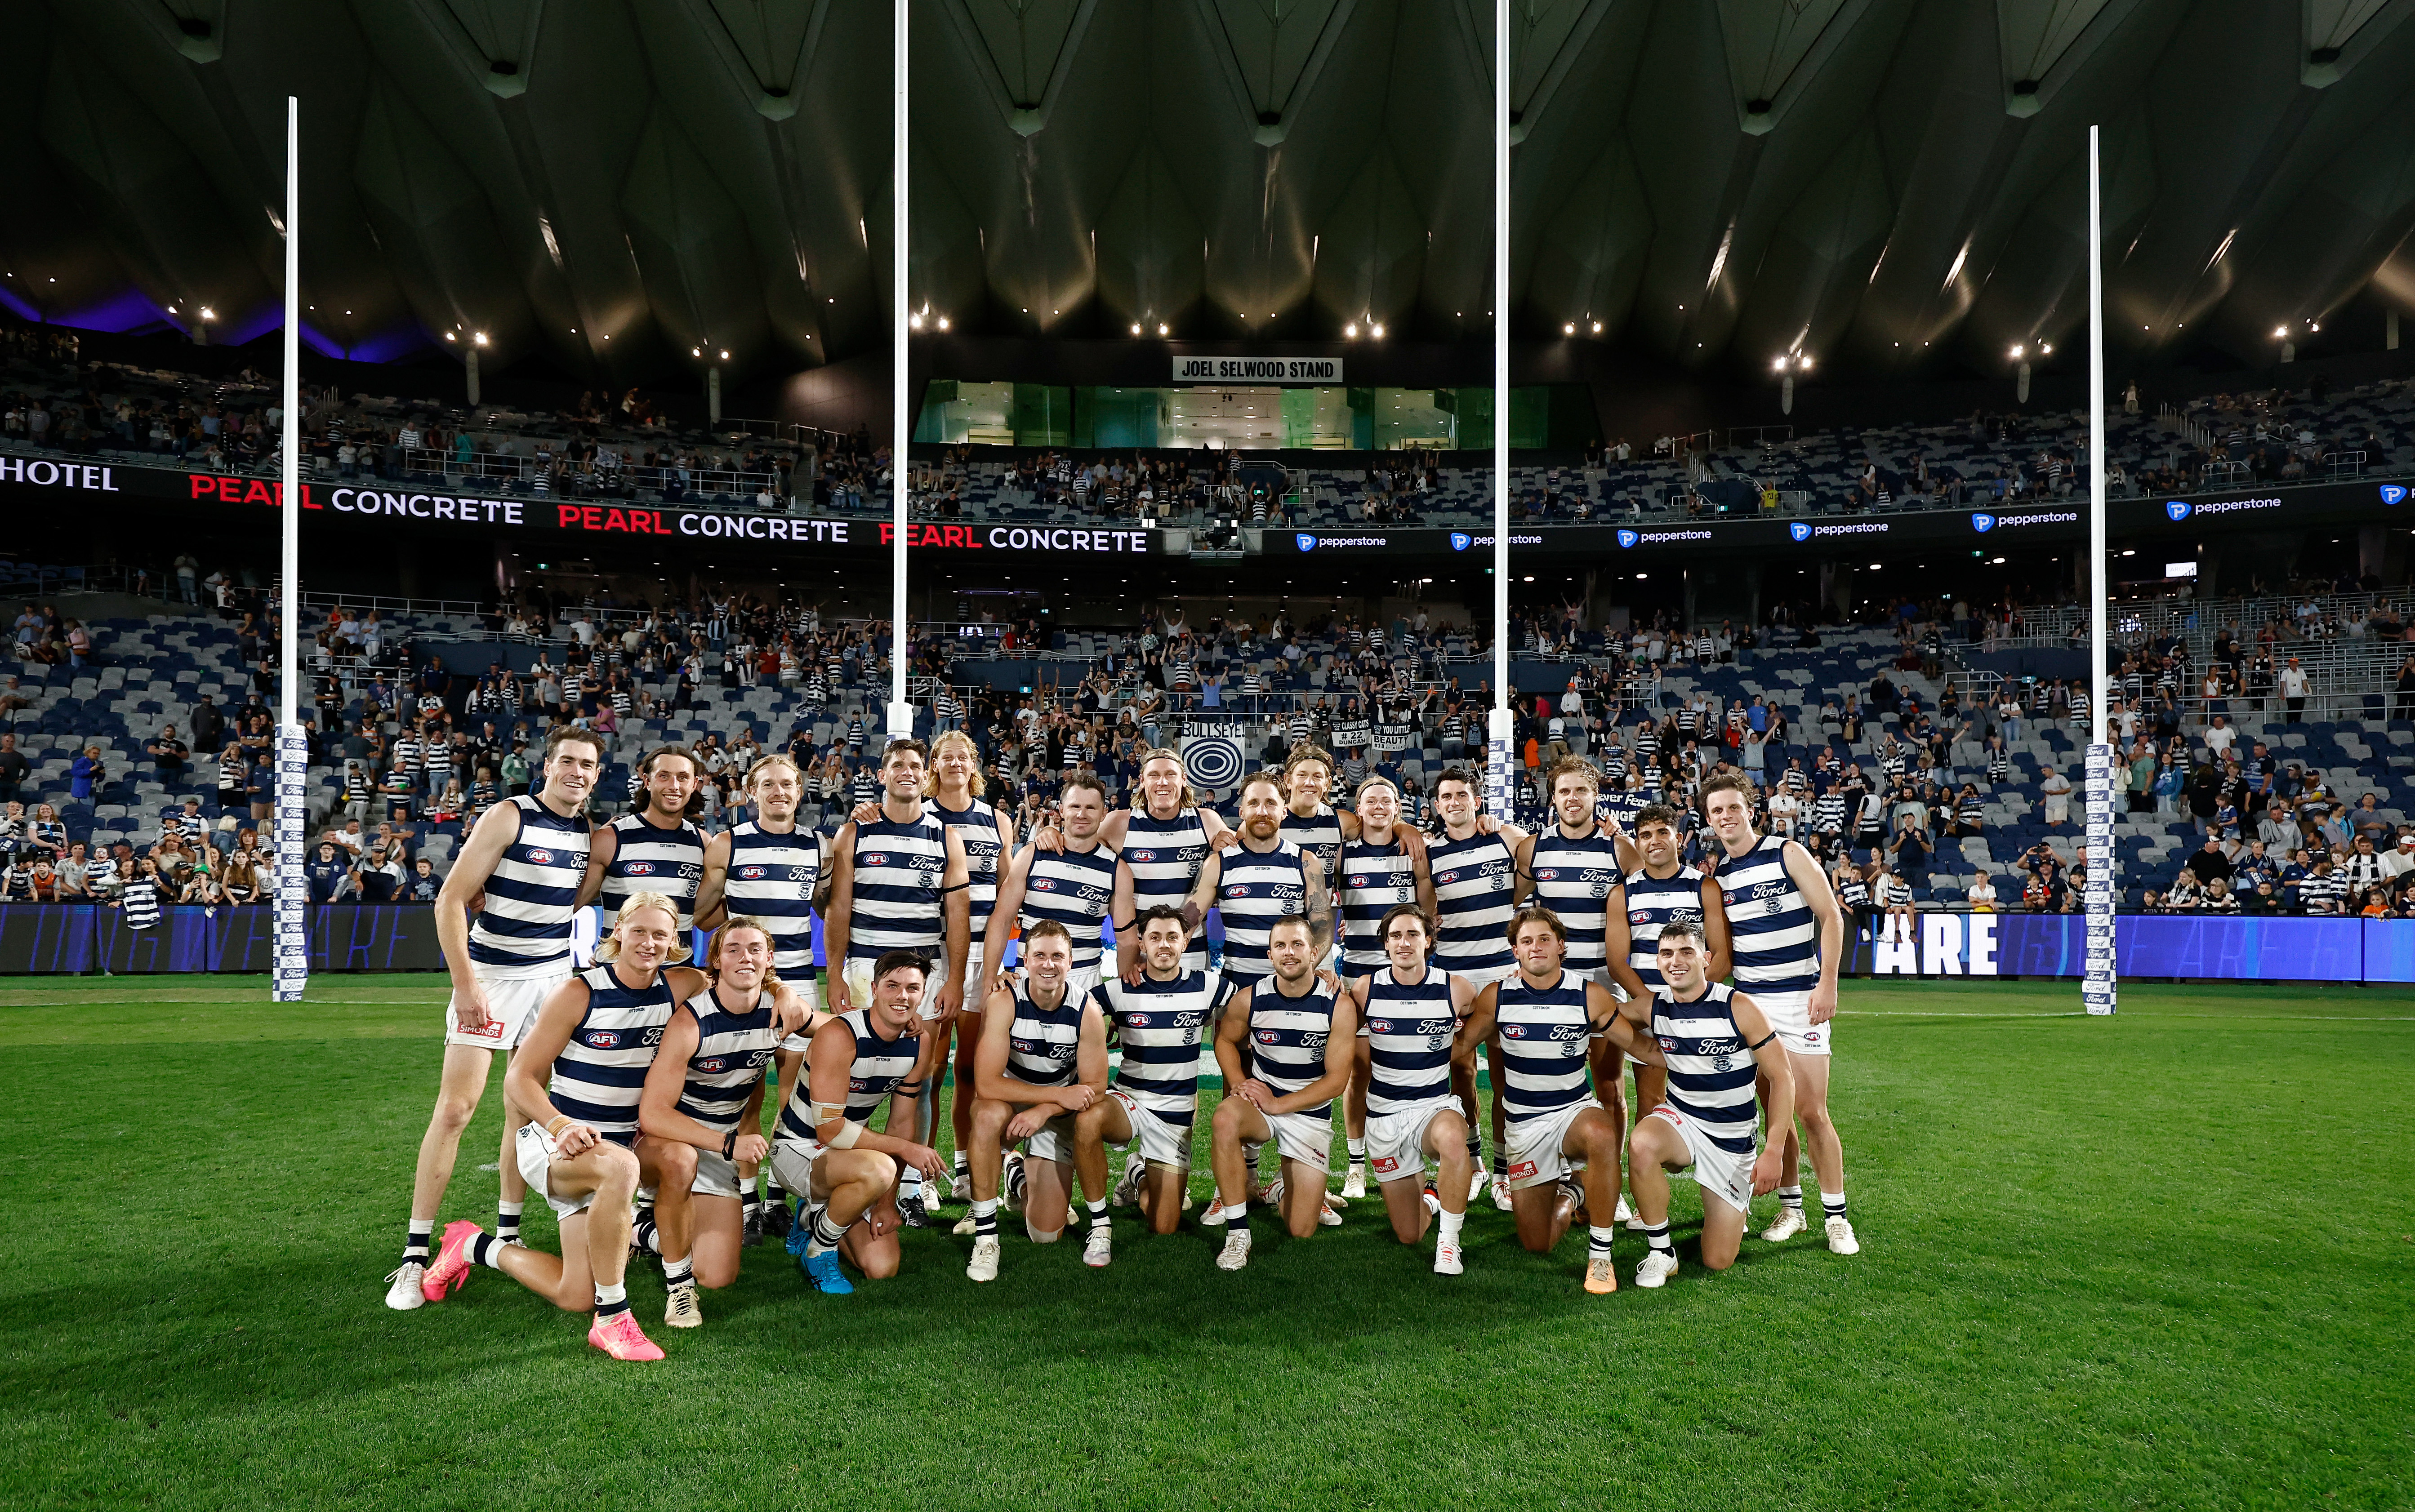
[387,727,604,1312]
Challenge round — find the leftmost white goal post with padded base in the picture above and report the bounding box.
[268,94,307,1002]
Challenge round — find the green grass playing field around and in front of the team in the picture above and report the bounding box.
[0,978,2415,1512]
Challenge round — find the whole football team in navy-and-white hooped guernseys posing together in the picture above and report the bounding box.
[387,727,1859,1360]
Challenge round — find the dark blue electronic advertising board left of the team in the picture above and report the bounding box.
[0,903,444,976]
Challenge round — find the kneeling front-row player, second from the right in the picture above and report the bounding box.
[1454,906,1662,1292]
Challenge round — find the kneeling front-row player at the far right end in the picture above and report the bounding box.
[1628,918,1794,1287]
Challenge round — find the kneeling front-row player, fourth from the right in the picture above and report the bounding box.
[1210,913,1357,1271]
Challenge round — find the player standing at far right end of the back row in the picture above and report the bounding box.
[1702,773,1862,1254]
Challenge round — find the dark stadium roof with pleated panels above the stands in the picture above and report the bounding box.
[0,0,2415,382]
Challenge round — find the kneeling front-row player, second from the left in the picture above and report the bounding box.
[637,916,811,1329]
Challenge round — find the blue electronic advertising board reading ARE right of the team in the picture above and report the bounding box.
[1845,913,2386,981]
